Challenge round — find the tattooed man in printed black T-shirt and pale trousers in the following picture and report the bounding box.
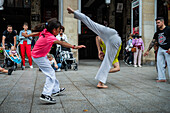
[144,17,170,82]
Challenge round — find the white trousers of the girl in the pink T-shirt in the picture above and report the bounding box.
[32,57,60,96]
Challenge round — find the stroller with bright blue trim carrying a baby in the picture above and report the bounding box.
[2,44,23,71]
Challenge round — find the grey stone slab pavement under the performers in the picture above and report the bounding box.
[0,60,170,113]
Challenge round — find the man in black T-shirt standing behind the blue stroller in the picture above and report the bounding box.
[2,25,16,49]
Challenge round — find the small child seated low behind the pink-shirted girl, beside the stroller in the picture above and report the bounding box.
[47,54,61,71]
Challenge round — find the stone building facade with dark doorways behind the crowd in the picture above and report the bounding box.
[0,0,170,63]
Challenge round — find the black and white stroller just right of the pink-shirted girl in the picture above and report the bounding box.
[56,46,78,71]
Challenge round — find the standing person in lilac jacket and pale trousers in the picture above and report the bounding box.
[132,36,144,67]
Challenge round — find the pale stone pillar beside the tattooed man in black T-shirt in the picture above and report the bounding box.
[142,0,155,63]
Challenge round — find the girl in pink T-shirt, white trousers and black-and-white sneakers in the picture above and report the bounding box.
[22,18,85,103]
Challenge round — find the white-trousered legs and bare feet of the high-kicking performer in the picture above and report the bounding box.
[67,7,122,88]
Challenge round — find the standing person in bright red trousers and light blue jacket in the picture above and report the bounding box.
[19,22,33,69]
